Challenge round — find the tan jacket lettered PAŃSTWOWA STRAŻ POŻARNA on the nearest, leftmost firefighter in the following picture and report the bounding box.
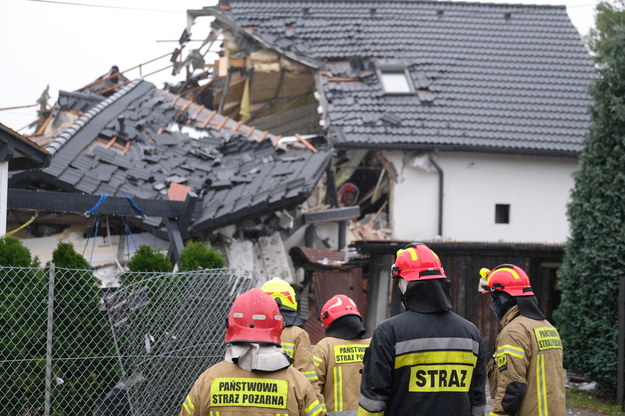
[180,361,326,416]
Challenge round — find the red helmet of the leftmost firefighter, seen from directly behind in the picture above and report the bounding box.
[225,288,284,345]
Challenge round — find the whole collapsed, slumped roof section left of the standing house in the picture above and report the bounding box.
[11,79,330,234]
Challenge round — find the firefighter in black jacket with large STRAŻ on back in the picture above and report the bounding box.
[358,243,486,416]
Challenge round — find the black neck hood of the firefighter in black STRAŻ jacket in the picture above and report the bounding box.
[402,279,451,313]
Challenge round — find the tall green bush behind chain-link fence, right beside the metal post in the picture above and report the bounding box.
[46,242,121,416]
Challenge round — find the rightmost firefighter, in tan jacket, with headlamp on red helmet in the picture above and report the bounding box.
[480,264,566,416]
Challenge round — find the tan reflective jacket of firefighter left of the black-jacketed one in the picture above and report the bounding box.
[313,337,371,416]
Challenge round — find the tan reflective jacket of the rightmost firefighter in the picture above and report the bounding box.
[488,306,566,416]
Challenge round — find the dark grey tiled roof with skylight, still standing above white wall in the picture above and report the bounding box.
[206,0,595,155]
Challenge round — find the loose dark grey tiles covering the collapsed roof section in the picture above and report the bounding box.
[37,80,331,233]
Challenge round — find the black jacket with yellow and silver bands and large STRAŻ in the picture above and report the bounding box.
[358,310,486,416]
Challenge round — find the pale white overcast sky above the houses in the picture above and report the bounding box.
[0,0,599,134]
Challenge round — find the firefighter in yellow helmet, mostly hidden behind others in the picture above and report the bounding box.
[262,277,323,394]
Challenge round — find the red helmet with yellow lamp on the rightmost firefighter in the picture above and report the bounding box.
[480,264,534,296]
